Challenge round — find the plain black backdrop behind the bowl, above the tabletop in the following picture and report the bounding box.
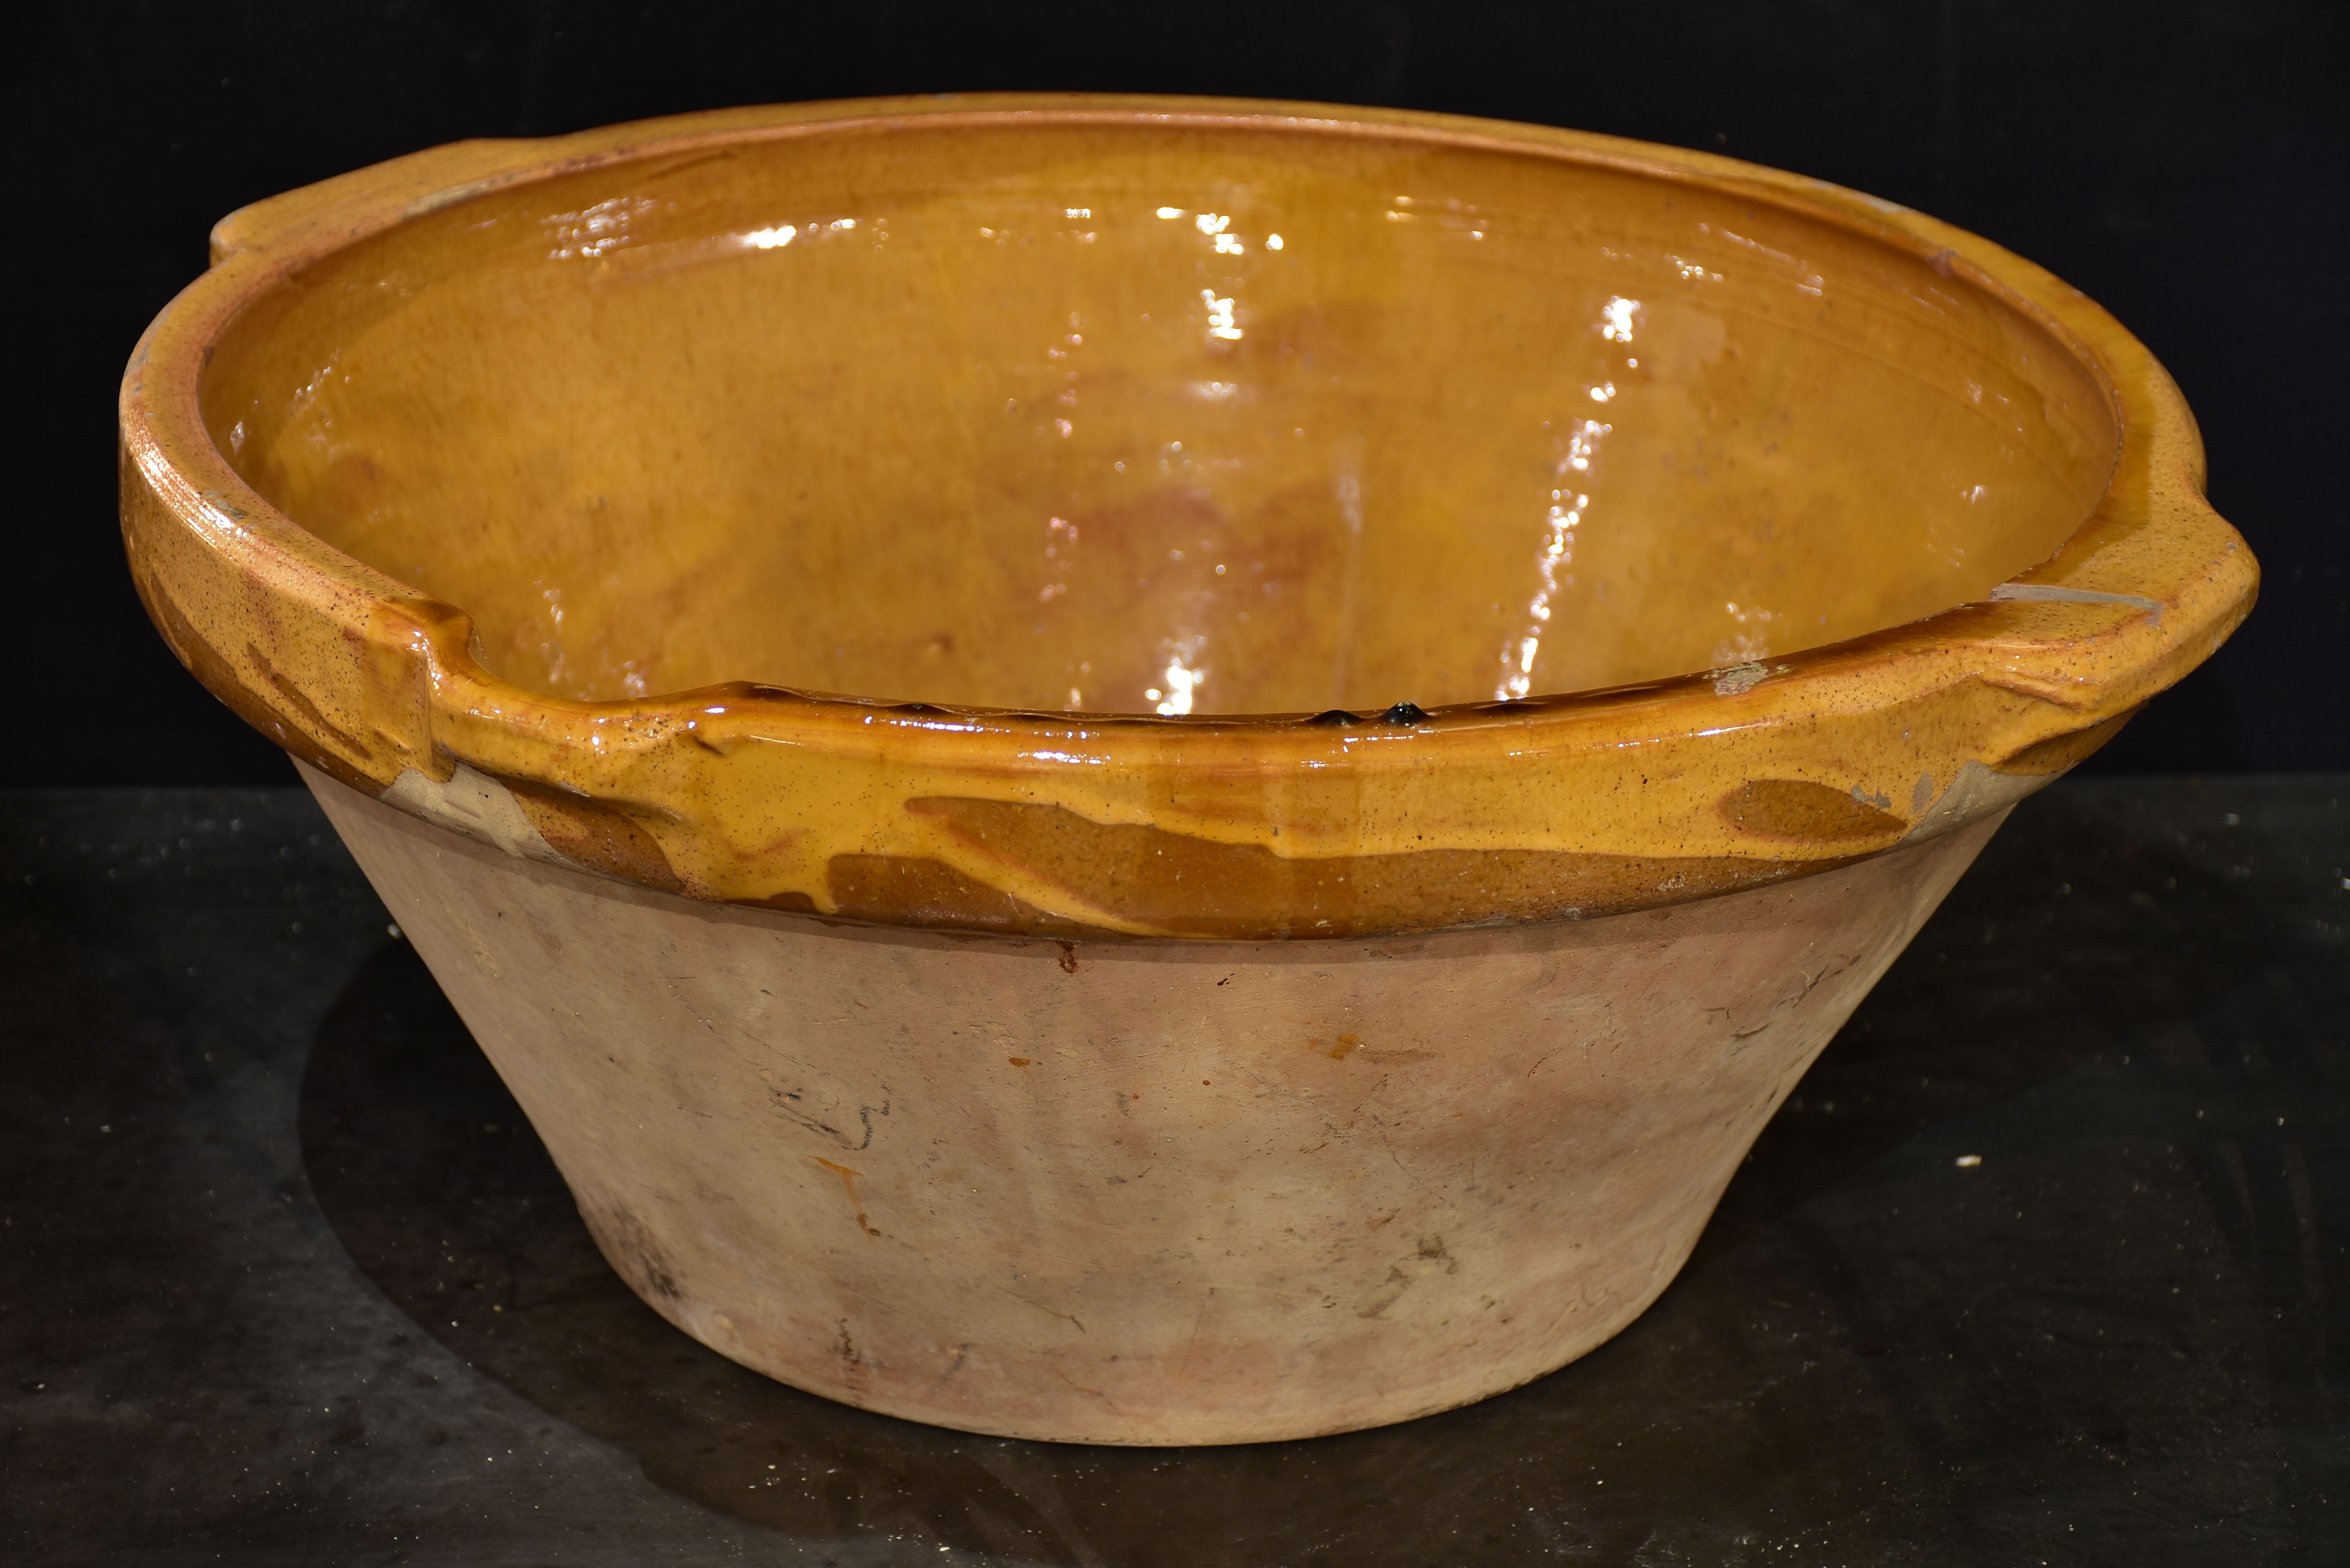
[0,0,2350,785]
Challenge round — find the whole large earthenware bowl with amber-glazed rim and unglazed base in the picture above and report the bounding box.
[122,96,2256,1444]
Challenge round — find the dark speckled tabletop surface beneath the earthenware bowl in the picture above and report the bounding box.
[0,776,2350,1568]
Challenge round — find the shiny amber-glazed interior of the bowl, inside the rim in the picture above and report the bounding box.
[202,115,2117,712]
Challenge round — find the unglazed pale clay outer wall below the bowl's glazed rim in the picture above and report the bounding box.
[308,774,2005,1444]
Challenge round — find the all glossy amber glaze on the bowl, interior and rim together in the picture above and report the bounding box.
[124,99,2256,938]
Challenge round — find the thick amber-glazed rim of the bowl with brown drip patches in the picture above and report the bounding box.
[120,94,2259,938]
